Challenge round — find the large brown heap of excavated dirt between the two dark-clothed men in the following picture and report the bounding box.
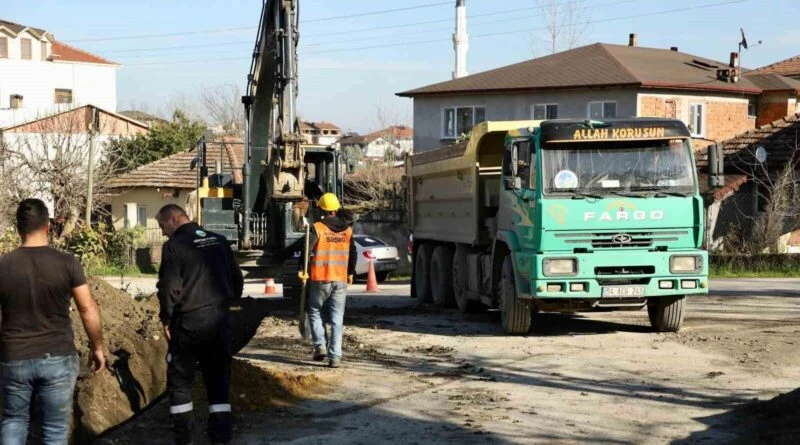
[0,278,276,445]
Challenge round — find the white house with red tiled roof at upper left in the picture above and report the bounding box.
[0,20,120,128]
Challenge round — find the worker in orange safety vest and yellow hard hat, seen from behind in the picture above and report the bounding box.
[298,193,357,368]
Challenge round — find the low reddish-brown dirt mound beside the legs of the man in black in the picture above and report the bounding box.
[192,359,320,412]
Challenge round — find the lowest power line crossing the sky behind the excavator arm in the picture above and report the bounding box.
[123,0,750,66]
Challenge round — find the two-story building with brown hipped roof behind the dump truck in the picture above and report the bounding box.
[398,35,800,152]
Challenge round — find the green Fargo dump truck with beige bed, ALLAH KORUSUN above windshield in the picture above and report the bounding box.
[406,118,718,334]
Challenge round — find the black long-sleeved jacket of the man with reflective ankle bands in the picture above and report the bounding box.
[158,223,244,325]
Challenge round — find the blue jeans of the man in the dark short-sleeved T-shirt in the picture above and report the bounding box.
[0,354,78,445]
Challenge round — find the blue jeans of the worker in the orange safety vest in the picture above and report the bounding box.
[308,281,347,359]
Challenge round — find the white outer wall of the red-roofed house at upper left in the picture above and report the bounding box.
[0,33,118,128]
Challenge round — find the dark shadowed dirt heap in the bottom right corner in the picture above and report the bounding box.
[734,389,800,445]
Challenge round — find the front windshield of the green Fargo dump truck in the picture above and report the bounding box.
[542,139,696,196]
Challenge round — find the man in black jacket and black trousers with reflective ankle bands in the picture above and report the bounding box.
[156,204,244,445]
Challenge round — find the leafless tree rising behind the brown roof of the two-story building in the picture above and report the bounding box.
[531,0,592,56]
